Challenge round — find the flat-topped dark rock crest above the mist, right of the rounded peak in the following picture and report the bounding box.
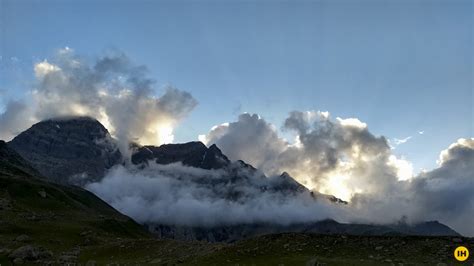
[132,141,230,169]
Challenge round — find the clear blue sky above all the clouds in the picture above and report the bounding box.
[0,0,474,170]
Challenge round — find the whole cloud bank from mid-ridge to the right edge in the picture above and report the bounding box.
[204,111,474,236]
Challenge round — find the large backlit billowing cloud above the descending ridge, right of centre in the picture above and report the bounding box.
[201,111,398,200]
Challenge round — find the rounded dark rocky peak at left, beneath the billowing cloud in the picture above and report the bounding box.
[8,117,122,184]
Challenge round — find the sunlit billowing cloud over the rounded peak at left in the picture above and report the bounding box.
[0,48,197,151]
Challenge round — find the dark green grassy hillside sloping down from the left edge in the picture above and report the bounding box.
[0,137,151,265]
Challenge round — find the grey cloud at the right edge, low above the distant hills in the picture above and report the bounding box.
[351,138,474,236]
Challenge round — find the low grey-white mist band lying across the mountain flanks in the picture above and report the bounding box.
[87,162,345,227]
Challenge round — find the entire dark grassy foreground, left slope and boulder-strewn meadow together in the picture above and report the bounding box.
[0,138,468,266]
